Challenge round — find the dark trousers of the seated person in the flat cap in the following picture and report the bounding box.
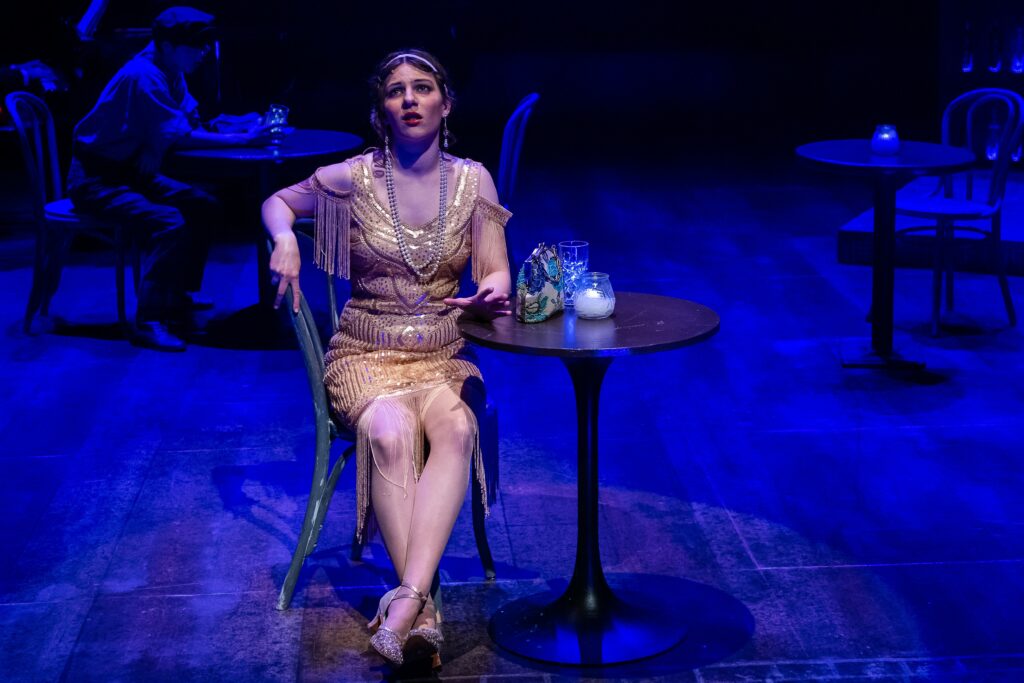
[68,159,221,322]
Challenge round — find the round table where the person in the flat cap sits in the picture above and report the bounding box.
[170,128,362,304]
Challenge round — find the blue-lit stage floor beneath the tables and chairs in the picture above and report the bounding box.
[0,157,1024,683]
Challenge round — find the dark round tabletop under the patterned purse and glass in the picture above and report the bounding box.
[459,292,719,357]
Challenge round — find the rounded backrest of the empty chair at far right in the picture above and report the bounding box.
[942,88,1024,207]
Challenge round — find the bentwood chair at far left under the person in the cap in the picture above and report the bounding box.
[4,92,139,332]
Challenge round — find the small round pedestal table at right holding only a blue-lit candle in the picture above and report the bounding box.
[797,139,975,368]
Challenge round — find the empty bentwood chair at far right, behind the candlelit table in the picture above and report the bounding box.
[896,88,1024,336]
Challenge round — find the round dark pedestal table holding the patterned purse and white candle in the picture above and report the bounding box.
[460,292,719,666]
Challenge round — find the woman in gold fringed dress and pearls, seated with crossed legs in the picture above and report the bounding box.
[263,49,511,665]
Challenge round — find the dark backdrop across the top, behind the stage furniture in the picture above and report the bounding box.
[2,0,1024,164]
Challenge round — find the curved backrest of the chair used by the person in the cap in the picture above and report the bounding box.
[4,92,63,220]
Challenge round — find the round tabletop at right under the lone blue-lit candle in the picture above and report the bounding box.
[797,139,975,174]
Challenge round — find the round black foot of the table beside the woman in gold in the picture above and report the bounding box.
[488,577,687,667]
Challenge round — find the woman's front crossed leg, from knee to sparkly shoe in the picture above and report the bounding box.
[386,383,482,633]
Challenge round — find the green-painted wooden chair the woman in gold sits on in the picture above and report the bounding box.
[278,225,498,610]
